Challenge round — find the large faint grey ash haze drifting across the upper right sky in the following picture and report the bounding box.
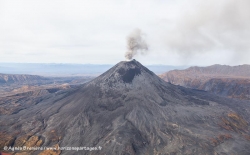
[161,0,250,63]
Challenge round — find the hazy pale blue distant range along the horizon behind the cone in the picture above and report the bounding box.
[0,63,187,76]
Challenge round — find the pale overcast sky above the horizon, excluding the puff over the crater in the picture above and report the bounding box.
[0,0,250,66]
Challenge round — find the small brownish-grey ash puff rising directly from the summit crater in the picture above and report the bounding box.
[125,29,148,60]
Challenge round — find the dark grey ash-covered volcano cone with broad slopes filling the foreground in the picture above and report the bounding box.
[0,60,250,155]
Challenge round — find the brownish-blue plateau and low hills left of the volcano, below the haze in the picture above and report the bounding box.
[0,73,93,97]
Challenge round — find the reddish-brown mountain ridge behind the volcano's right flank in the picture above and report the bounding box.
[160,65,250,100]
